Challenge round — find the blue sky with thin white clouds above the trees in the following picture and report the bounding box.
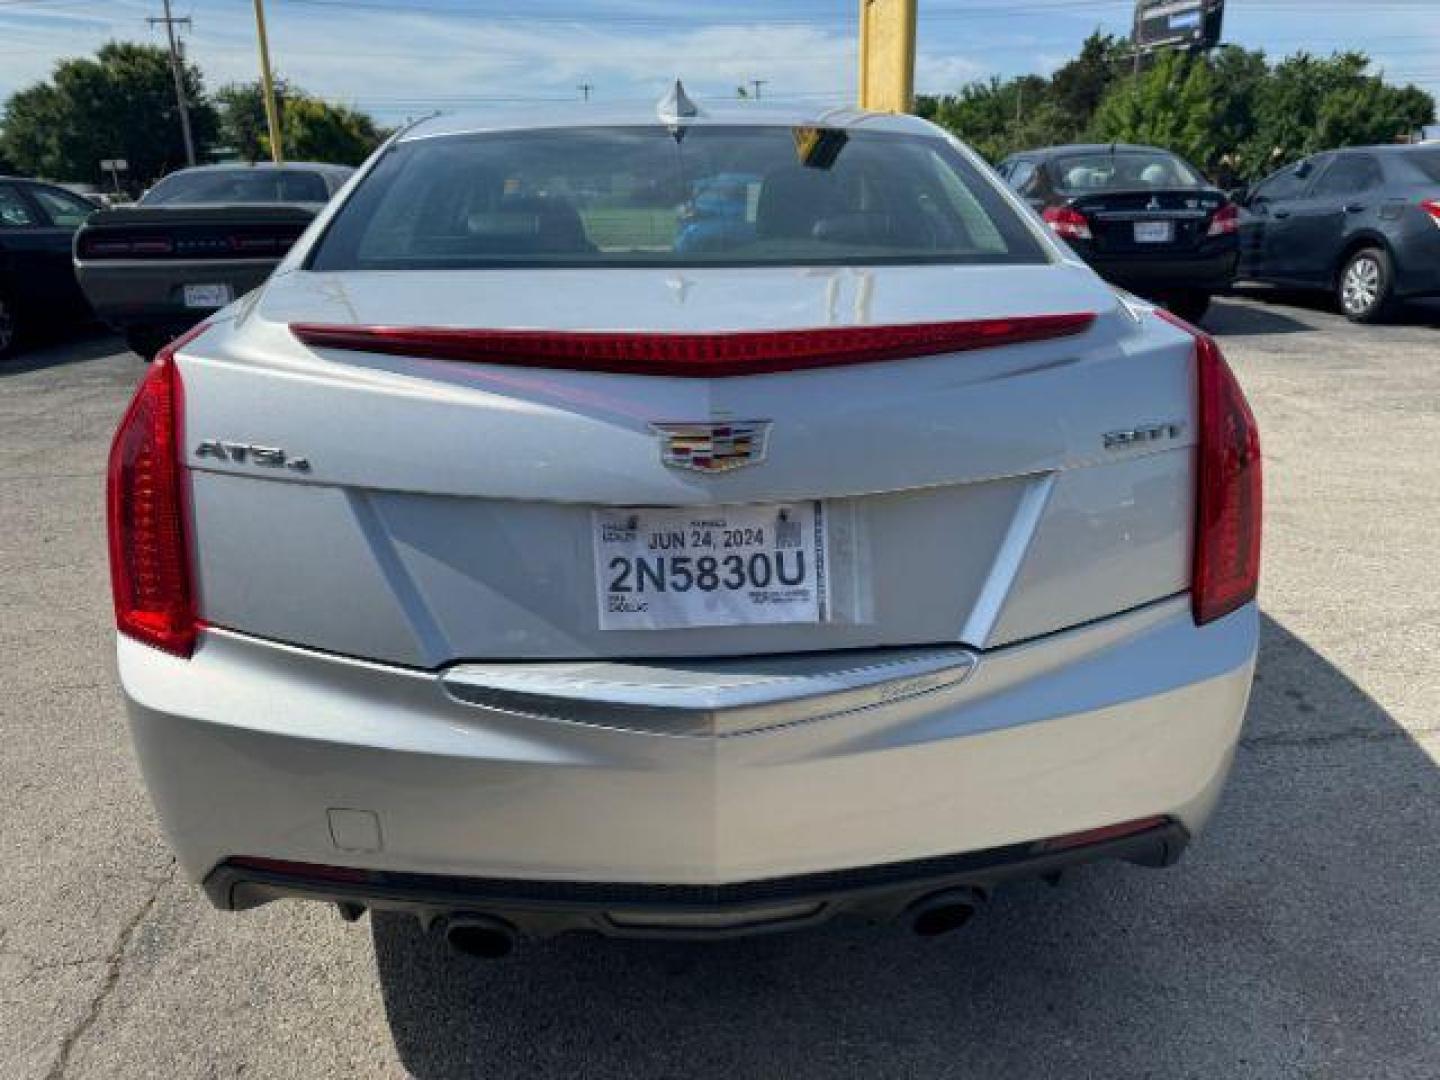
[0,0,1440,122]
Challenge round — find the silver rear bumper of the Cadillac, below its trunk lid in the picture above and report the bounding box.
[120,598,1257,904]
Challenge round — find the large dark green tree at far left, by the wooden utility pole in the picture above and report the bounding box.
[0,42,217,189]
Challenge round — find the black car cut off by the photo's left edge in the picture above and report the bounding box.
[0,176,98,360]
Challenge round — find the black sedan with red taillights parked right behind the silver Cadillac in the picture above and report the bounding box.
[999,143,1238,321]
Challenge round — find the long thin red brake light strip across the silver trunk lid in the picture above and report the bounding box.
[289,312,1094,379]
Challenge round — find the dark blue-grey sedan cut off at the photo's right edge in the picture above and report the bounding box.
[1238,145,1440,323]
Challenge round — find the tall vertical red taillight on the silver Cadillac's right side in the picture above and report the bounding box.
[1155,310,1261,626]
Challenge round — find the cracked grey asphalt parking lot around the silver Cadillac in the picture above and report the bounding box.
[0,298,1440,1080]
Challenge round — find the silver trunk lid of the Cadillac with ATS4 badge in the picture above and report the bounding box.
[181,265,1192,667]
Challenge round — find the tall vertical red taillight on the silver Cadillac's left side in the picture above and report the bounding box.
[105,325,206,657]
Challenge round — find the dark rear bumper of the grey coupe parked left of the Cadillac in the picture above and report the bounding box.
[75,259,279,330]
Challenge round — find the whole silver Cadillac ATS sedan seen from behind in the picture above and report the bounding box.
[108,94,1261,956]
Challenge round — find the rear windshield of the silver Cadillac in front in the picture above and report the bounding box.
[310,125,1044,271]
